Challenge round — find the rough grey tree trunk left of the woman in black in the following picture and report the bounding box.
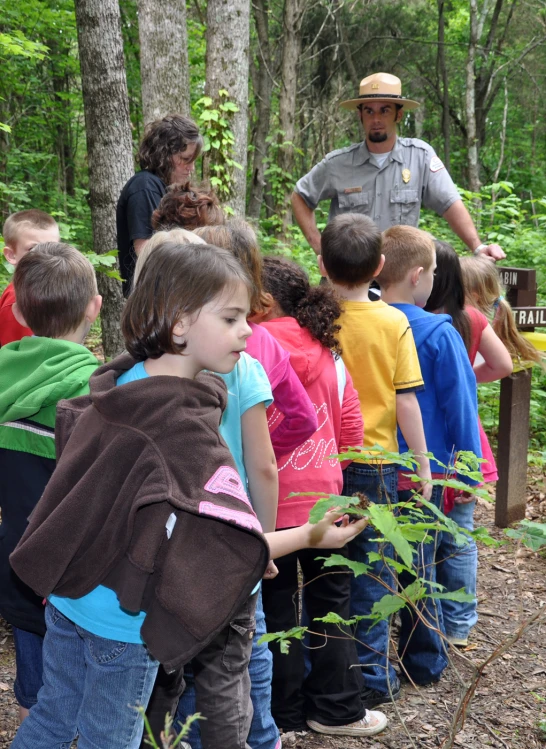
[76,0,134,357]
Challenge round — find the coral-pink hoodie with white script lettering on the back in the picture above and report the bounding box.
[262,317,364,528]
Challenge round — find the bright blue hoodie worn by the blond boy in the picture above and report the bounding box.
[392,304,482,485]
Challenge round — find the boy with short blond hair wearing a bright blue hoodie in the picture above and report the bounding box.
[379,226,481,684]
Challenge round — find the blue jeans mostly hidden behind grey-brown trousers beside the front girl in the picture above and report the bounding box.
[175,588,281,749]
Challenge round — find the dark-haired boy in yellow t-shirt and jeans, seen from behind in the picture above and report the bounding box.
[319,213,432,708]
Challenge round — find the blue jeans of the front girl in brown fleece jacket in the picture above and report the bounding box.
[11,604,159,749]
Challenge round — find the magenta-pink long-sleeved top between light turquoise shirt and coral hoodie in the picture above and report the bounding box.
[246,323,318,460]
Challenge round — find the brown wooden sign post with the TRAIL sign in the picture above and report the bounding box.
[495,268,532,528]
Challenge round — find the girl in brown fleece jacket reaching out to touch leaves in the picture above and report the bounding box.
[11,242,363,749]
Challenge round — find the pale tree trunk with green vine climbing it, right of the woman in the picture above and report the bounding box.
[204,0,250,216]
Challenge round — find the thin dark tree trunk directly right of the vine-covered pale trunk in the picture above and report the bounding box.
[247,0,273,218]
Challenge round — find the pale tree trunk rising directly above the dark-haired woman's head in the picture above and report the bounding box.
[138,0,190,125]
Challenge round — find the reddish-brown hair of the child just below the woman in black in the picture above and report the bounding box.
[152,182,225,231]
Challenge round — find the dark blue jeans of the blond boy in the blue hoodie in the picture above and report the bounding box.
[398,486,448,684]
